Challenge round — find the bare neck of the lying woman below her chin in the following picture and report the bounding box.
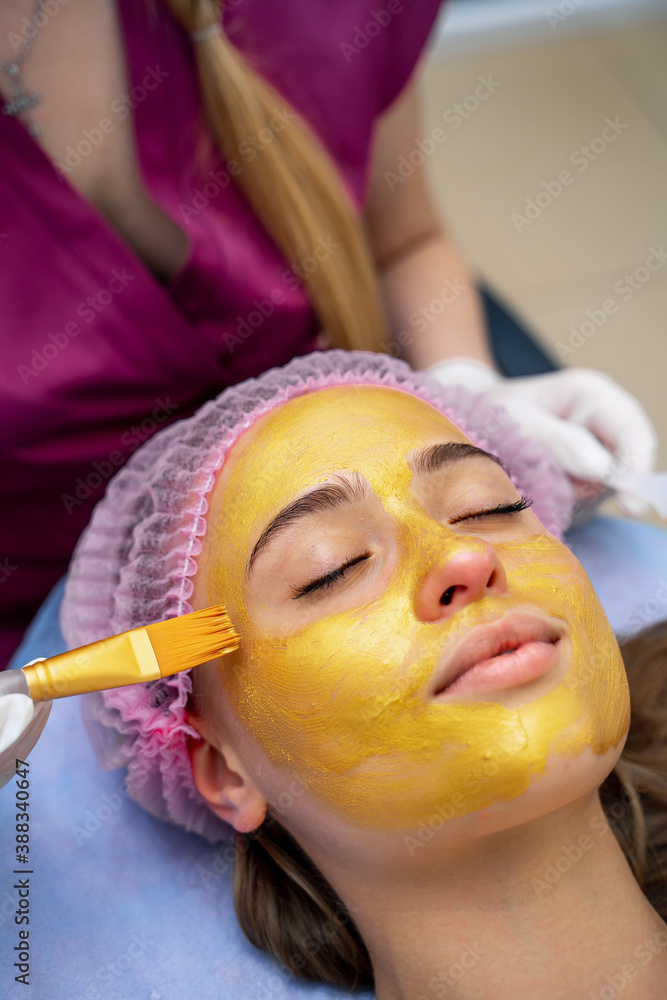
[320,793,667,1000]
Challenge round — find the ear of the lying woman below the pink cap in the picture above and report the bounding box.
[187,737,267,833]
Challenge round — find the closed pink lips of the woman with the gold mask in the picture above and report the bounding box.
[432,614,565,697]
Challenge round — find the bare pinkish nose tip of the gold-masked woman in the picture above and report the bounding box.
[417,542,507,622]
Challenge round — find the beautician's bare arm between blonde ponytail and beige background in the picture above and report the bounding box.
[365,77,493,368]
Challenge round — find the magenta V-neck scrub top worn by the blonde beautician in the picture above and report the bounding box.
[0,0,446,669]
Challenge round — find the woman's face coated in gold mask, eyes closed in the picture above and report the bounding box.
[201,386,629,830]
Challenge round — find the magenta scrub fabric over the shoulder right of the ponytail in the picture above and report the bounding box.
[224,0,441,194]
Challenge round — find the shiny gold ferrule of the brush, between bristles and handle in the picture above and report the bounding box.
[23,628,162,701]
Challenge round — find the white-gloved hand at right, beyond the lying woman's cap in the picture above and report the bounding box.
[430,358,658,516]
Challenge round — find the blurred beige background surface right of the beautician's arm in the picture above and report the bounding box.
[422,18,667,480]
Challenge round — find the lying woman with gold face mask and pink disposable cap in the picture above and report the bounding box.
[63,351,667,1000]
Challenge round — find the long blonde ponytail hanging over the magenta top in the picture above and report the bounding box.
[168,0,386,351]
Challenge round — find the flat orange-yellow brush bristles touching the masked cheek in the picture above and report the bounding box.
[146,604,239,677]
